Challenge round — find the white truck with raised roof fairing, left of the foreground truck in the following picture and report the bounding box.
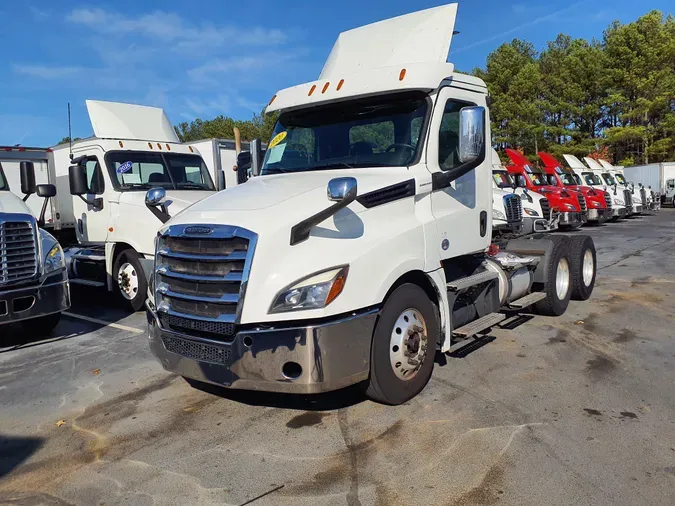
[48,100,216,311]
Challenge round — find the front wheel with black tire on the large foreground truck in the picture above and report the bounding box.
[366,283,440,405]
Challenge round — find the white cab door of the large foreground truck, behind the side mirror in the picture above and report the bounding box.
[426,87,492,259]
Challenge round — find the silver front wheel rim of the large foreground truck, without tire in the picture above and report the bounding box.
[389,308,429,381]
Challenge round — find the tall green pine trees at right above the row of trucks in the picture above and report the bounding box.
[473,11,675,166]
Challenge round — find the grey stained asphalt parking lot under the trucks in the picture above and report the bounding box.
[0,209,675,506]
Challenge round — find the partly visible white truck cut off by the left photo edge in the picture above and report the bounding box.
[0,162,70,338]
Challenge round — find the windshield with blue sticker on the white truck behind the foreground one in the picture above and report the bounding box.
[105,151,215,191]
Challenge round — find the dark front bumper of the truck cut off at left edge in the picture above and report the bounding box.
[0,271,70,325]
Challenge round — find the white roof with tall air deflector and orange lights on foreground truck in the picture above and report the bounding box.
[265,3,476,114]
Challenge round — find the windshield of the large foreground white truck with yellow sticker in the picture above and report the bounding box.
[262,92,429,175]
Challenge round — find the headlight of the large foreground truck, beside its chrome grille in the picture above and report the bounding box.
[269,265,349,313]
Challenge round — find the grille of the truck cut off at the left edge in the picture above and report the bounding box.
[0,215,38,285]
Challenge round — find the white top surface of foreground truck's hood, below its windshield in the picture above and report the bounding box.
[167,167,412,232]
